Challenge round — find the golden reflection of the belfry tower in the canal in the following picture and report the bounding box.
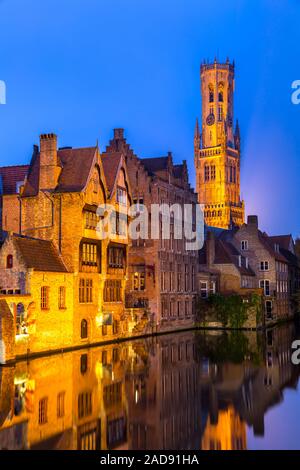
[201,406,247,450]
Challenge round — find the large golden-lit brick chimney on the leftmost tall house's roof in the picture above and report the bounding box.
[39,134,61,189]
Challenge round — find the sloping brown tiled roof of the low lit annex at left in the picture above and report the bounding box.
[13,235,68,273]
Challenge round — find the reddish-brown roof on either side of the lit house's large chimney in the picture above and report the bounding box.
[22,147,97,197]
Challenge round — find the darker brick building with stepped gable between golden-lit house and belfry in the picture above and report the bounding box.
[103,129,198,329]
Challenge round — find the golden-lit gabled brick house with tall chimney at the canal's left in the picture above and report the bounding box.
[0,134,133,355]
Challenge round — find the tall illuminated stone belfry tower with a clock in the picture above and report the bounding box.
[194,59,245,229]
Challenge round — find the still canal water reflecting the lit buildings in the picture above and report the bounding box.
[0,324,300,450]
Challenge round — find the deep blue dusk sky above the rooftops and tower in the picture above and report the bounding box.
[0,0,300,235]
